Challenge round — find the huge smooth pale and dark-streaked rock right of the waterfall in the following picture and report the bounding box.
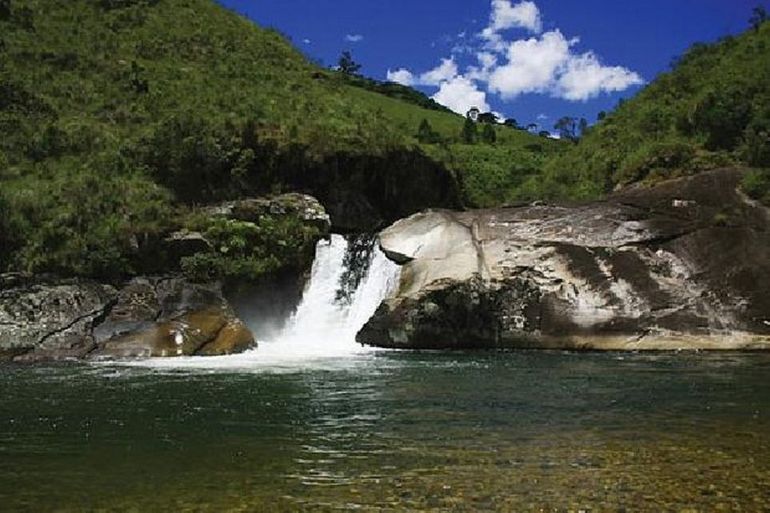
[358,170,770,350]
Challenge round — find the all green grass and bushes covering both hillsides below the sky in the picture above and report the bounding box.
[0,0,770,278]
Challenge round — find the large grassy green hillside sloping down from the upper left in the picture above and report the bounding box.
[0,0,561,276]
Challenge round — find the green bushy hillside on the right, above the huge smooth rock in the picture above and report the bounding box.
[543,23,770,198]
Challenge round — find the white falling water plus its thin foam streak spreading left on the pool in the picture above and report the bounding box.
[116,235,400,369]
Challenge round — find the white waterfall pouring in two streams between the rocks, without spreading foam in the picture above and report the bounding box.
[255,235,399,359]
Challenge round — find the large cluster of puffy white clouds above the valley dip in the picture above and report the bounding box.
[388,0,644,113]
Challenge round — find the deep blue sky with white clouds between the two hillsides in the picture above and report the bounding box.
[220,0,770,129]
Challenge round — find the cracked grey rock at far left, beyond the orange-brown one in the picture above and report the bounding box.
[0,279,117,360]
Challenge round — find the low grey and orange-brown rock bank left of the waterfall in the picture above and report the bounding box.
[0,278,255,362]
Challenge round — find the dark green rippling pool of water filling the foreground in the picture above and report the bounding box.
[0,352,770,512]
